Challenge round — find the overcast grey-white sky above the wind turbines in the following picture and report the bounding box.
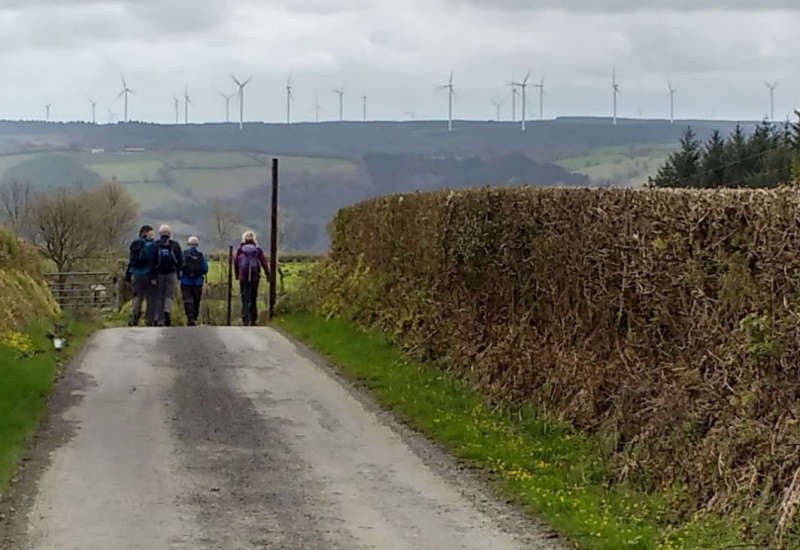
[0,0,800,122]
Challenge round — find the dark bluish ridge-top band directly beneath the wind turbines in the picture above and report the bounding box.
[0,117,757,159]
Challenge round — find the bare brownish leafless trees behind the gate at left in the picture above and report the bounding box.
[0,180,139,272]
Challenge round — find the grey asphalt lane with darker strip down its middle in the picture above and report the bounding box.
[0,328,559,550]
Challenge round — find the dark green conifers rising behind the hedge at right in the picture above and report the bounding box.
[648,117,800,189]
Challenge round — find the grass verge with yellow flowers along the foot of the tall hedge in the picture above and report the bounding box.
[275,314,766,550]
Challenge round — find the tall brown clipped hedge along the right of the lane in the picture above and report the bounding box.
[316,188,800,540]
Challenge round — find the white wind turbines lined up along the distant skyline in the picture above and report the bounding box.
[45,68,778,132]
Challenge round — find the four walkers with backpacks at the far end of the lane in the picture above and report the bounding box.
[125,225,270,327]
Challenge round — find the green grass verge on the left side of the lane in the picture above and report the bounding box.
[0,321,95,494]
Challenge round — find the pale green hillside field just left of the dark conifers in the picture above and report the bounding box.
[556,144,678,187]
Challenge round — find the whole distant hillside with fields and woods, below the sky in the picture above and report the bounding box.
[0,118,753,250]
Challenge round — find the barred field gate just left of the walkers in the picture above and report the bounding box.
[46,271,121,312]
